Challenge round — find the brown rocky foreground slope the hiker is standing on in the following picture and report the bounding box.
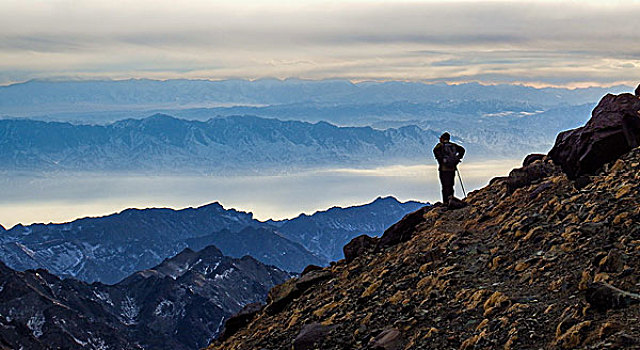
[210,85,640,350]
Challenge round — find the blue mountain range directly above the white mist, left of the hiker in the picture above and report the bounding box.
[0,114,438,175]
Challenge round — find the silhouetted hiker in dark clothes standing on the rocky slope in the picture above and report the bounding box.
[433,132,465,205]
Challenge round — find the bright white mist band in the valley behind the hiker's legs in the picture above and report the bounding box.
[0,160,521,229]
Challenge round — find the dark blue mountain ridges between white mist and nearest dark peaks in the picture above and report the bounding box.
[0,197,424,283]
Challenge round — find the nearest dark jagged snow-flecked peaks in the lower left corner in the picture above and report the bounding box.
[0,246,290,349]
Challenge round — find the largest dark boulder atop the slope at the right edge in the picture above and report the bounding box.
[549,90,640,179]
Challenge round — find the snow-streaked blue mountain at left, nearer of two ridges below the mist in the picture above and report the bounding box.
[0,203,327,283]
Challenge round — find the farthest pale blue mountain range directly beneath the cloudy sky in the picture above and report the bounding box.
[0,79,629,116]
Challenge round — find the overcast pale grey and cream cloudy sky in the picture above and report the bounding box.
[0,0,640,87]
